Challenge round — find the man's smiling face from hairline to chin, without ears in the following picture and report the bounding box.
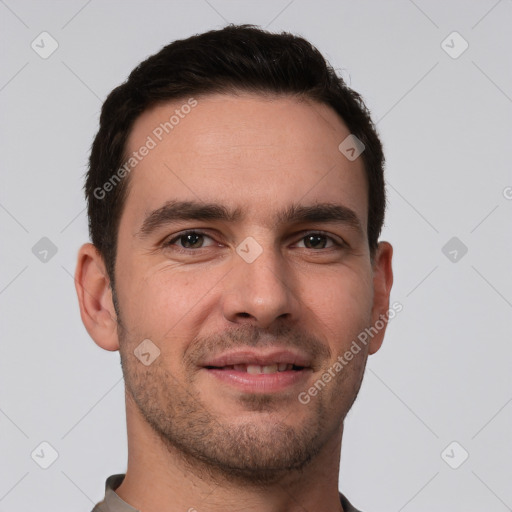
[111,95,383,481]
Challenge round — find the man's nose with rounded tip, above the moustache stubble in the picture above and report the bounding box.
[223,243,300,328]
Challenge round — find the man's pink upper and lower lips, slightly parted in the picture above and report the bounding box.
[200,347,313,393]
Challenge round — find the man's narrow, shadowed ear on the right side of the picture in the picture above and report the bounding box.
[368,242,393,354]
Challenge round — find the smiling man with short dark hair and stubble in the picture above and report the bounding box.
[76,26,392,512]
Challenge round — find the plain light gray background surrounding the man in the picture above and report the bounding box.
[0,0,512,512]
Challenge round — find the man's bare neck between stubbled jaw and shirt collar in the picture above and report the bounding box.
[116,393,343,512]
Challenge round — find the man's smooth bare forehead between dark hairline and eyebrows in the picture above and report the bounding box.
[123,94,367,229]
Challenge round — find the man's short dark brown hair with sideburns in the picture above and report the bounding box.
[84,25,386,286]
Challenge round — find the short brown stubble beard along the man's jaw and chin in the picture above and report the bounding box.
[118,308,364,486]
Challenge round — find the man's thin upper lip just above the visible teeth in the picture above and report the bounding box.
[200,348,311,373]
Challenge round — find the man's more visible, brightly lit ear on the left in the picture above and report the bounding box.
[75,243,119,350]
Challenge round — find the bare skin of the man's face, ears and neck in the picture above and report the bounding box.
[76,94,393,512]
